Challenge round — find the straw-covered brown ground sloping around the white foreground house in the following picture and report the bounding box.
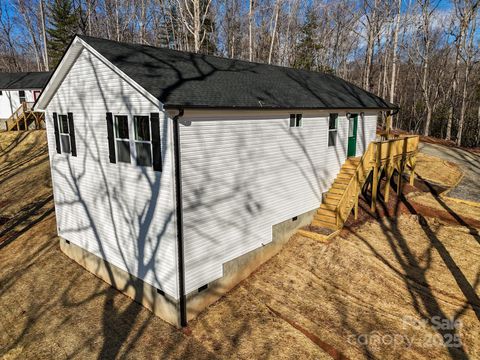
[0,132,480,359]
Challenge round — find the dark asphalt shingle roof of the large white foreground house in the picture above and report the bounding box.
[79,35,395,109]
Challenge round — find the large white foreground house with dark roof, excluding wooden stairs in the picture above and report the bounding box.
[35,36,394,326]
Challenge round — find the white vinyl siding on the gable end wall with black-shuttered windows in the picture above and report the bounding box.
[42,49,178,298]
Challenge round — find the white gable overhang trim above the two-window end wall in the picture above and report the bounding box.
[33,36,163,111]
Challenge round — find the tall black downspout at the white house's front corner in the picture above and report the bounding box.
[172,109,187,327]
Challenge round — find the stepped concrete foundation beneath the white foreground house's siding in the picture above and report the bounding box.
[60,209,316,327]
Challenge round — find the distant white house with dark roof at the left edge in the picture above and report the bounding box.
[0,71,51,130]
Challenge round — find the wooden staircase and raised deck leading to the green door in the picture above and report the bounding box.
[308,136,419,235]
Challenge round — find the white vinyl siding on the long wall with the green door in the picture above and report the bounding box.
[180,111,376,293]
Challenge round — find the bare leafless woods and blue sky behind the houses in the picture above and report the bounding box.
[0,0,480,146]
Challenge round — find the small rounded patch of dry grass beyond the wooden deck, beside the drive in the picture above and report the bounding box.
[415,153,462,187]
